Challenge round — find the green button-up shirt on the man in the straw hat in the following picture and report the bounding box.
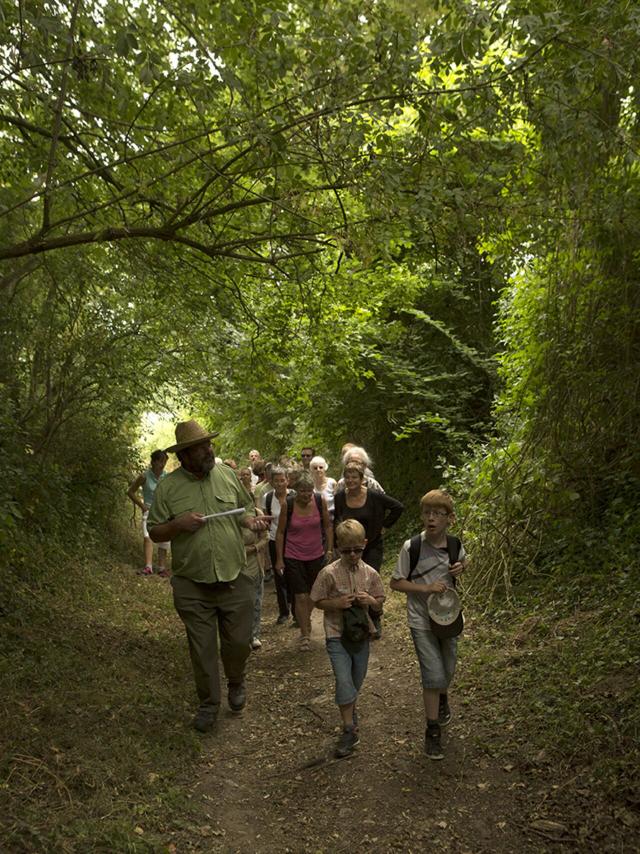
[147,465,255,584]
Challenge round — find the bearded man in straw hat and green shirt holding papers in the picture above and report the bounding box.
[147,420,270,732]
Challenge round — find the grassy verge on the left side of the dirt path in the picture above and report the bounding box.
[0,544,200,852]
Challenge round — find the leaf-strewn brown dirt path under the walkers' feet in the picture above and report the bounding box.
[174,585,556,854]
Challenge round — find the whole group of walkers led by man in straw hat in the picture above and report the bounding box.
[128,420,466,759]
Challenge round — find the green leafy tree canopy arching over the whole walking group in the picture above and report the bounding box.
[0,0,640,587]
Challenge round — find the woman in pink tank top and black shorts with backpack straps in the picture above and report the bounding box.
[275,472,333,650]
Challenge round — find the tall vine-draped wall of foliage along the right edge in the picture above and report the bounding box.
[440,4,640,594]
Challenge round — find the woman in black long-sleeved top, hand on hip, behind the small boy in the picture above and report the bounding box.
[334,462,404,572]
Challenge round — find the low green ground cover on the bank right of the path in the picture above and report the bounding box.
[456,564,640,824]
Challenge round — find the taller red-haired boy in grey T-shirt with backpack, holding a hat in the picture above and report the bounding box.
[390,489,466,759]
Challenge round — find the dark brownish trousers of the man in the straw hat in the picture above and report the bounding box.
[171,572,255,714]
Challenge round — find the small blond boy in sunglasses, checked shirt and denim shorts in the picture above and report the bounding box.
[311,519,384,759]
